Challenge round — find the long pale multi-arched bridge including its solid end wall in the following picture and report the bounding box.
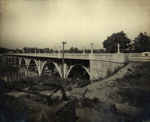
[3,53,129,80]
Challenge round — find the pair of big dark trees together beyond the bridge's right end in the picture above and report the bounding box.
[103,31,150,53]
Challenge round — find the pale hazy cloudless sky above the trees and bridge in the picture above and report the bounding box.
[0,0,150,49]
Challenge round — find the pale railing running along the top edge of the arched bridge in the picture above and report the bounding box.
[4,53,150,61]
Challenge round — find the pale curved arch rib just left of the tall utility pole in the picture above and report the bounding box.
[39,60,62,78]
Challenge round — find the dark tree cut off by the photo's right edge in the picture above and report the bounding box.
[132,32,150,53]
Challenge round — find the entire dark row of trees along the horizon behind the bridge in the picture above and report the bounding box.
[0,31,150,53]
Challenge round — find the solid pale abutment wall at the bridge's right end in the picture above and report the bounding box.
[90,53,128,80]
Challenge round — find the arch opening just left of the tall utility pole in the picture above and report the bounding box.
[41,60,61,78]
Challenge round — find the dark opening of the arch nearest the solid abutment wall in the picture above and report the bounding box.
[67,64,90,80]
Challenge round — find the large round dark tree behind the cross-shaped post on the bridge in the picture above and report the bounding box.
[103,31,131,53]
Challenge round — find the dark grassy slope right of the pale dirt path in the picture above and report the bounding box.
[116,62,150,108]
